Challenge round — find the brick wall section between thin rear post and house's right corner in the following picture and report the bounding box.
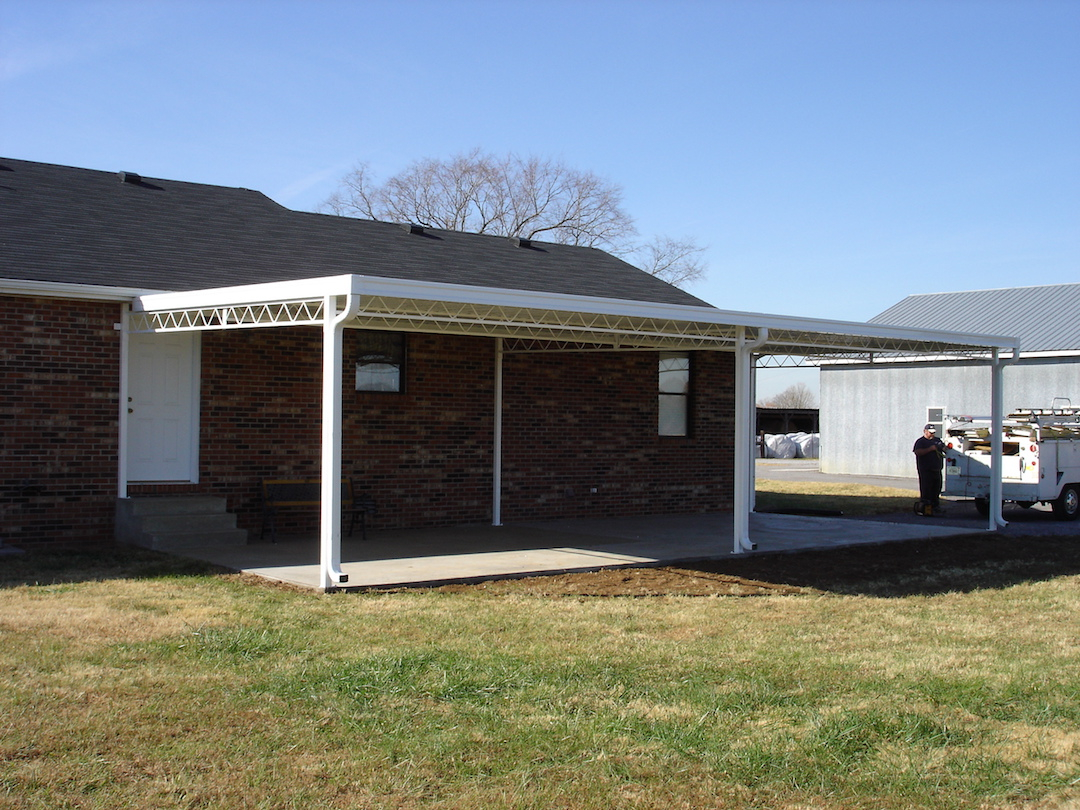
[503,352,734,519]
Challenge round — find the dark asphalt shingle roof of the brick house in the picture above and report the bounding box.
[0,158,708,306]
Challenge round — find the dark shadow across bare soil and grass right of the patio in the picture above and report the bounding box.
[693,528,1080,597]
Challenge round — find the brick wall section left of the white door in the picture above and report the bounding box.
[0,296,121,545]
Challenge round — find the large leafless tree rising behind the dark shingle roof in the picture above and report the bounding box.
[320,149,705,286]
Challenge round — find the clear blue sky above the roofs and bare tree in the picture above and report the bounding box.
[0,0,1080,399]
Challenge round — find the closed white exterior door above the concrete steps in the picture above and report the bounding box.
[127,332,199,482]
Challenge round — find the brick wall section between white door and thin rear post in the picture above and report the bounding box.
[201,328,495,532]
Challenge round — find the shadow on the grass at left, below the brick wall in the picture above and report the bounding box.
[0,545,228,588]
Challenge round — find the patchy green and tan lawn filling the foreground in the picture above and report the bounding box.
[0,540,1080,810]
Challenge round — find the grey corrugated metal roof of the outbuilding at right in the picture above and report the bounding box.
[869,283,1080,352]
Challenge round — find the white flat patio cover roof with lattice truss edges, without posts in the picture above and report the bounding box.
[131,274,1020,360]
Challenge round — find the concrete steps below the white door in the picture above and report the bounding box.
[116,495,247,552]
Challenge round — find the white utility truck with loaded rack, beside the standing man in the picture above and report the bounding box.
[942,401,1080,521]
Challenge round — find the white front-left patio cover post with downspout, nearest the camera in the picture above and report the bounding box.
[319,295,360,591]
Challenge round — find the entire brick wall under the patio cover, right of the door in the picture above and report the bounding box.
[201,328,734,531]
